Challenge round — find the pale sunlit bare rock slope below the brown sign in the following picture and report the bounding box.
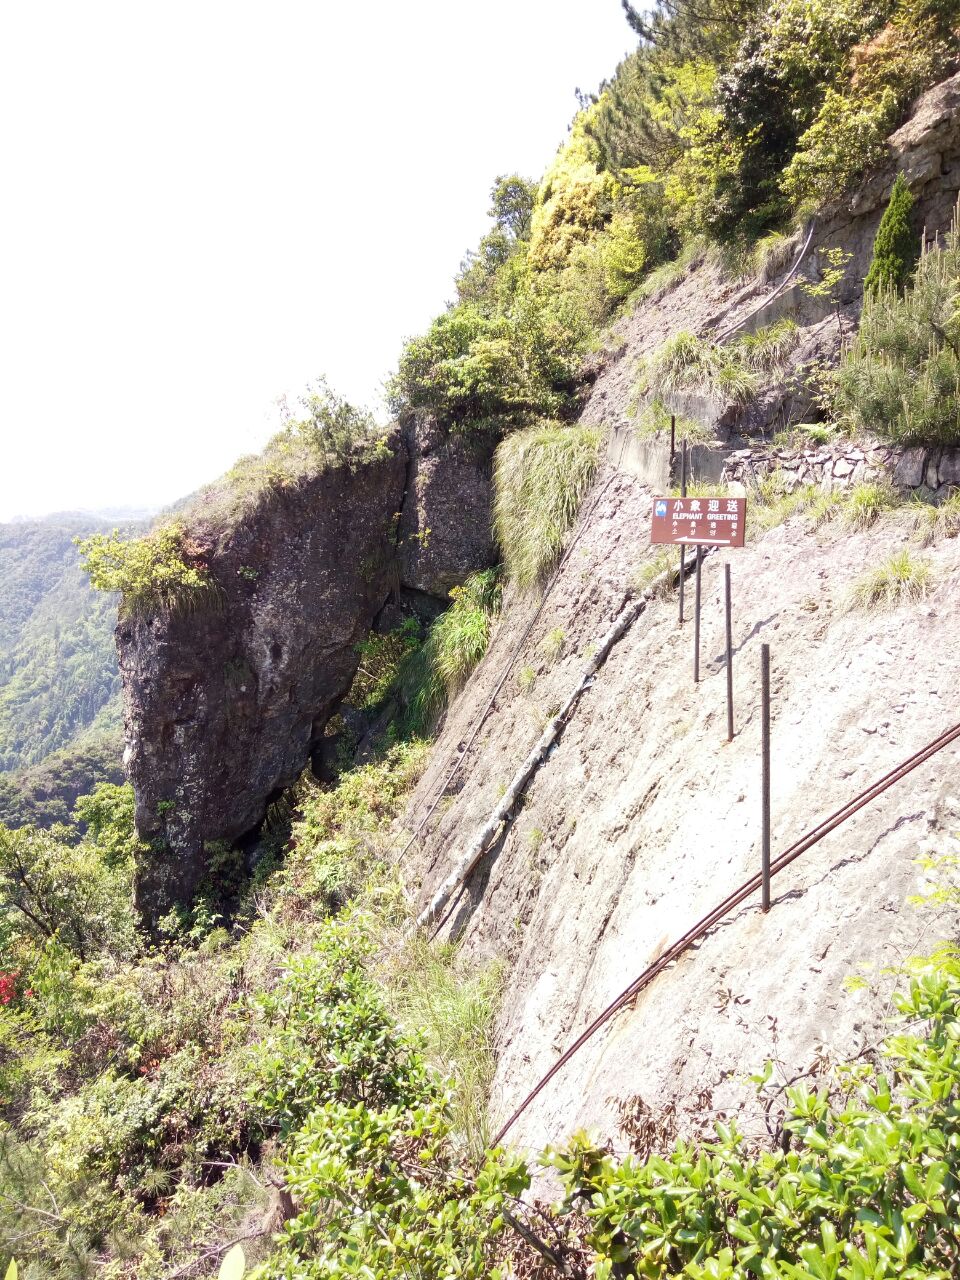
[410,475,960,1172]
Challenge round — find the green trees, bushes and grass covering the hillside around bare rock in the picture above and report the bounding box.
[0,0,960,1280]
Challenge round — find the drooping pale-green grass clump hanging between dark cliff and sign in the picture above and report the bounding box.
[494,422,602,588]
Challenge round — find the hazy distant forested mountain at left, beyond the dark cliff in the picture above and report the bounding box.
[0,512,146,824]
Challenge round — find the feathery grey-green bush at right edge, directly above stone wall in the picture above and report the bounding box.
[836,208,960,444]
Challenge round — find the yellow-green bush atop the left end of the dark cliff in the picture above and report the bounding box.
[76,520,220,617]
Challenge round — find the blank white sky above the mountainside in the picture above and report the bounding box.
[0,0,632,520]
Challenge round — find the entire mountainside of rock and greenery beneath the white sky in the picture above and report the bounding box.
[0,0,960,1280]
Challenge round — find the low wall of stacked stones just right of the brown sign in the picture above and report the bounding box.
[723,444,960,498]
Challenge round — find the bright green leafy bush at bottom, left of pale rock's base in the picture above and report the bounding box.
[251,918,529,1280]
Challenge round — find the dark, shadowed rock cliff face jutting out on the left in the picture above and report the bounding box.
[116,438,407,920]
